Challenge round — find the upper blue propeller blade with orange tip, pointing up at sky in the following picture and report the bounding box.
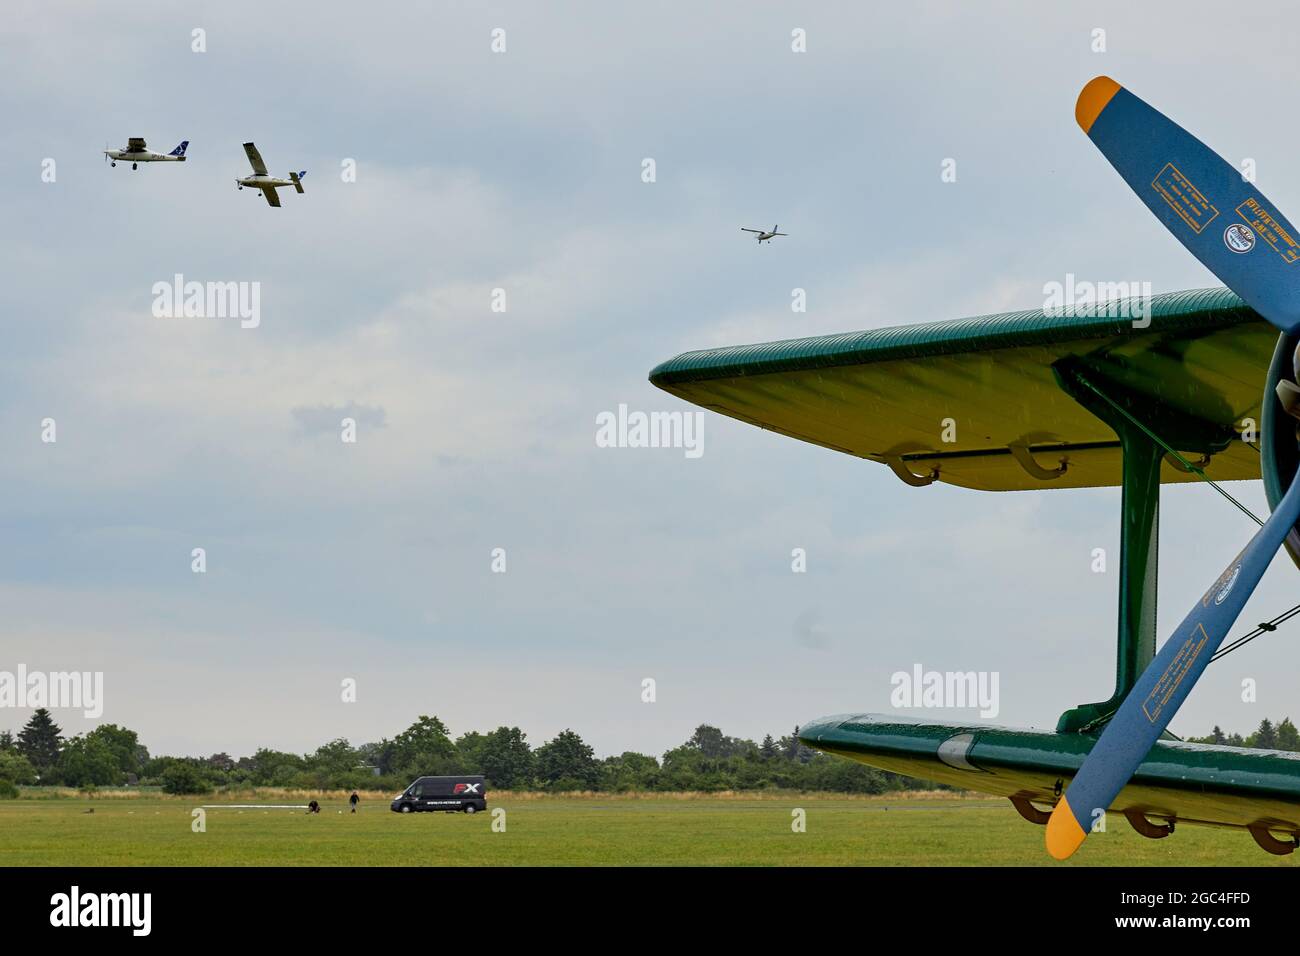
[1075,77,1300,332]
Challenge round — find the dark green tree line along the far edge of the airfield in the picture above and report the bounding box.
[0,709,1300,797]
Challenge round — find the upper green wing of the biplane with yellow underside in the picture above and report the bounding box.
[650,289,1278,492]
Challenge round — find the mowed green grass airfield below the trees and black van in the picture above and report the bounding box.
[0,795,1300,866]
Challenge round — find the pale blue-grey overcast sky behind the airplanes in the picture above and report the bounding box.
[0,0,1300,754]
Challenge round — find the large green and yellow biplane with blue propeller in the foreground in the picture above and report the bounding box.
[650,77,1300,858]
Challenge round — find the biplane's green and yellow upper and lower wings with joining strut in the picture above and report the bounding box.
[650,289,1300,855]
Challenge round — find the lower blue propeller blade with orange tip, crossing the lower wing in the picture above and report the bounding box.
[1047,476,1300,860]
